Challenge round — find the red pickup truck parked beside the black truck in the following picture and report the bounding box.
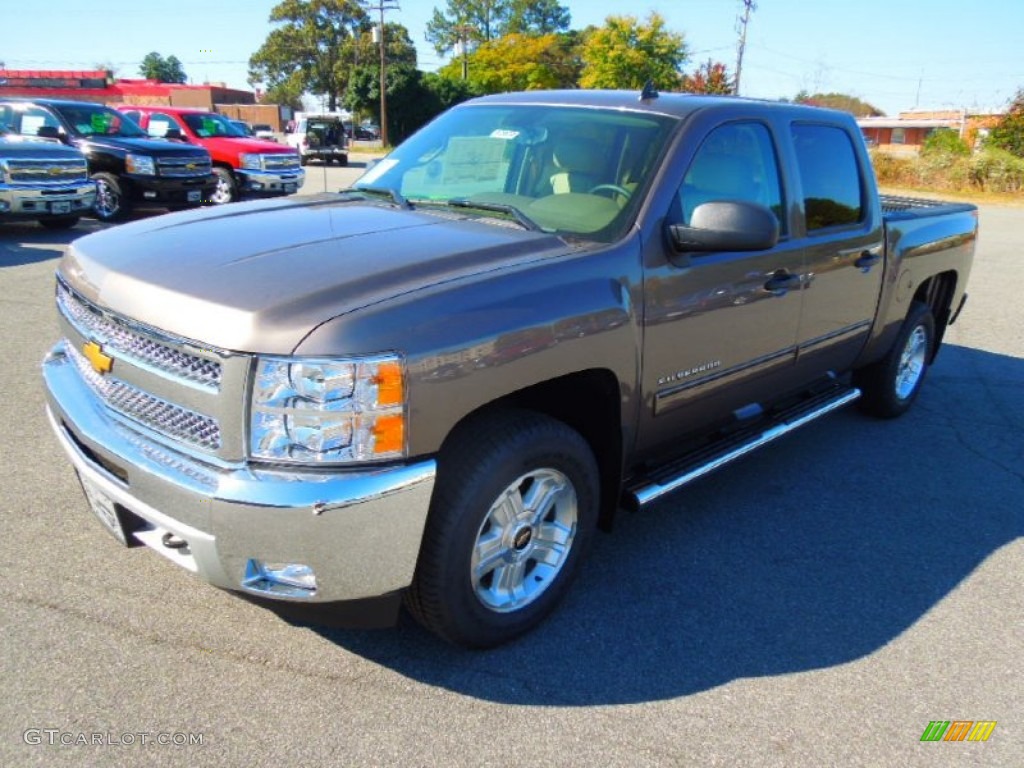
[118,104,305,205]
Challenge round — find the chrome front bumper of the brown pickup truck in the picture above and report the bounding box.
[43,342,436,602]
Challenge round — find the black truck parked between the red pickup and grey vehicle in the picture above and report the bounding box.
[0,98,217,221]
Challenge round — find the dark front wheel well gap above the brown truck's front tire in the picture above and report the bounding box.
[441,369,623,530]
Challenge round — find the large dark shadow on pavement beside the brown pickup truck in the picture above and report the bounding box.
[299,346,1024,706]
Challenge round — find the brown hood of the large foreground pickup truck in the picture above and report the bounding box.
[59,195,569,354]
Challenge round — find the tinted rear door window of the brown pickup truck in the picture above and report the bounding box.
[793,123,864,231]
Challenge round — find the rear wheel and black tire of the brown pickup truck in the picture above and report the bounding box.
[853,301,935,419]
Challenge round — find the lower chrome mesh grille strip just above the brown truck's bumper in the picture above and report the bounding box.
[65,344,220,451]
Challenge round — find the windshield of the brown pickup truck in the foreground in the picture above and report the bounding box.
[355,104,675,241]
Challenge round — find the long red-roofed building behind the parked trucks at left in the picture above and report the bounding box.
[0,70,282,131]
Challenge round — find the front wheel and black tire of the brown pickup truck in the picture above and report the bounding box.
[406,411,599,648]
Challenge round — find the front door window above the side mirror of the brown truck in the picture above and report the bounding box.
[679,123,785,234]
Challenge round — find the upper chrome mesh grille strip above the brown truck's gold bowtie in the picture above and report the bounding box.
[57,280,222,392]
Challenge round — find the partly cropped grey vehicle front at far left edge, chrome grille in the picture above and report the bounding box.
[0,124,96,229]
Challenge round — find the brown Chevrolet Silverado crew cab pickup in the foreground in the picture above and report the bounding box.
[44,90,977,646]
